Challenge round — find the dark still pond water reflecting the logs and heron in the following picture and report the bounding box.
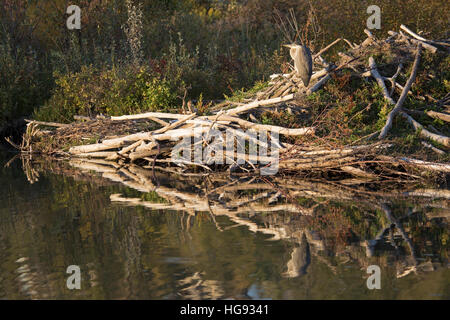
[0,152,450,299]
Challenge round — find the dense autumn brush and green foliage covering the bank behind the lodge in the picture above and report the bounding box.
[0,0,450,128]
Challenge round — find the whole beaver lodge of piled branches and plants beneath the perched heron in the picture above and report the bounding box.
[11,25,450,185]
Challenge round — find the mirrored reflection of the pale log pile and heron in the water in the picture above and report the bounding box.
[23,159,450,277]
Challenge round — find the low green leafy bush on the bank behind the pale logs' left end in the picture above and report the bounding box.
[34,66,176,122]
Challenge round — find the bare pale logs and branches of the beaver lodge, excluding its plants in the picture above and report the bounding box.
[14,25,450,179]
